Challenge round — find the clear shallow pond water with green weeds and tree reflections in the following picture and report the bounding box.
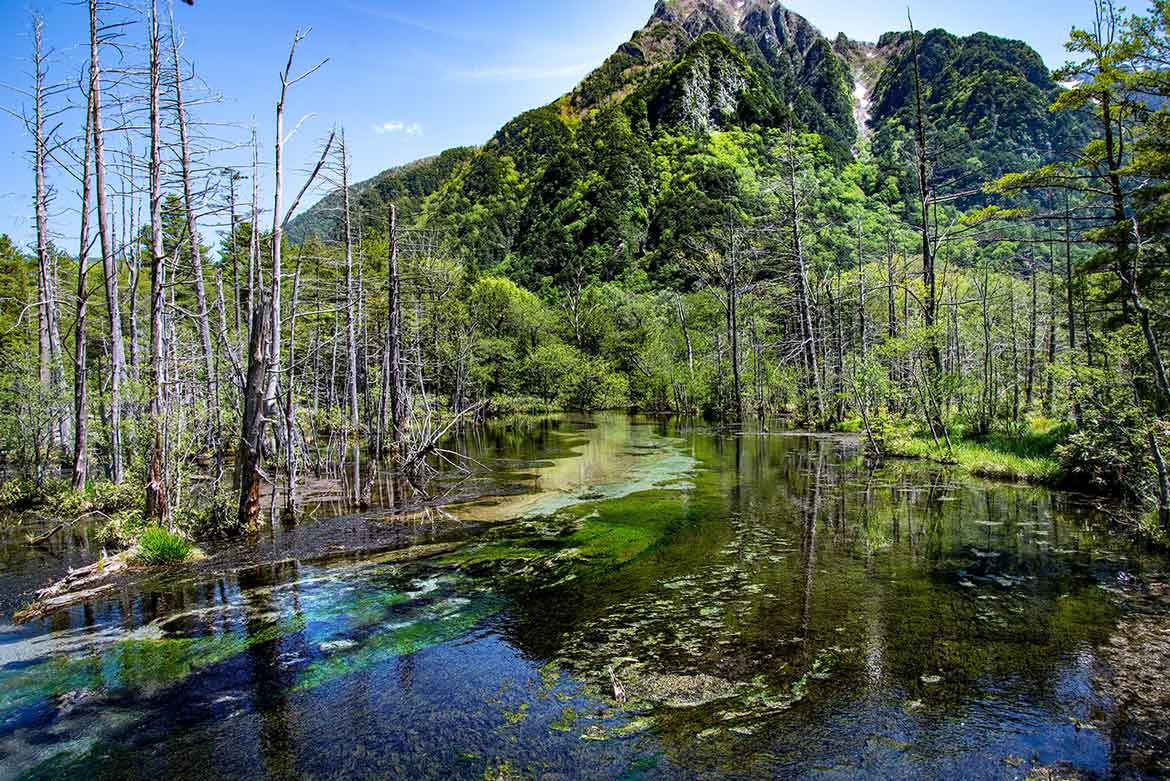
[0,416,1166,779]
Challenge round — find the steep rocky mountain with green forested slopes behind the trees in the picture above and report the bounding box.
[289,0,1078,288]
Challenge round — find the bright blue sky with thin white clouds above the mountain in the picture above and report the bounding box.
[0,0,1092,248]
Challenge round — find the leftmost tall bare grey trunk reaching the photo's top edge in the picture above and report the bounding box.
[89,0,126,483]
